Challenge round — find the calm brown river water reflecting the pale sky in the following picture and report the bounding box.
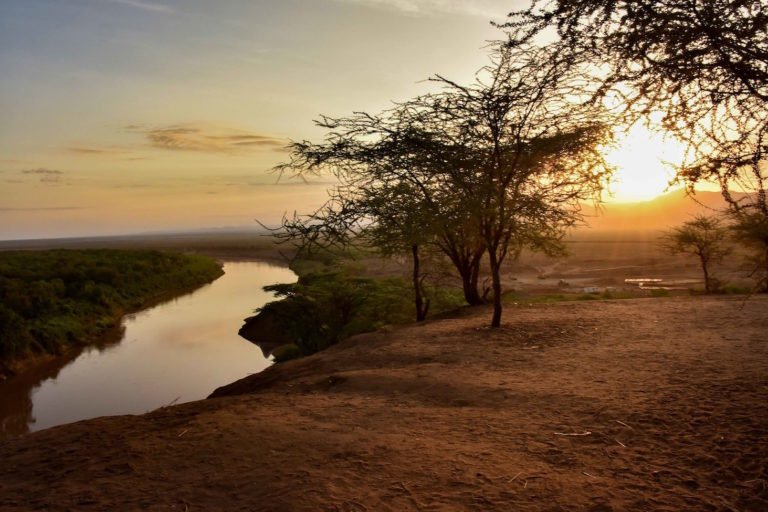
[0,262,296,437]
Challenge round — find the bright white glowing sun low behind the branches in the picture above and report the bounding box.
[605,124,684,203]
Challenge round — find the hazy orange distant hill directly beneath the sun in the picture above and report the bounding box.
[574,190,726,238]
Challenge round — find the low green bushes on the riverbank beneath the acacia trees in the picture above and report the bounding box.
[259,271,461,357]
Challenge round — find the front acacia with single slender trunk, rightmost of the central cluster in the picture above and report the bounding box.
[408,45,609,327]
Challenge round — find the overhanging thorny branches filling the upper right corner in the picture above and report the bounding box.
[501,0,768,280]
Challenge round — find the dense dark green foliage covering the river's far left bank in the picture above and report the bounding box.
[0,250,222,362]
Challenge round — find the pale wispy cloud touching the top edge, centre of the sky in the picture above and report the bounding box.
[336,0,508,18]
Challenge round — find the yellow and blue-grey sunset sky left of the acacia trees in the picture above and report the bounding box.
[0,0,684,239]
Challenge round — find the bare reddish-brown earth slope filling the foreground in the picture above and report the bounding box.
[0,297,768,512]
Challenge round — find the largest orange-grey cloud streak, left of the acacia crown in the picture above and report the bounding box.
[130,124,287,153]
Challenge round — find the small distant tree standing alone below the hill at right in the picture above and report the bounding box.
[663,215,729,293]
